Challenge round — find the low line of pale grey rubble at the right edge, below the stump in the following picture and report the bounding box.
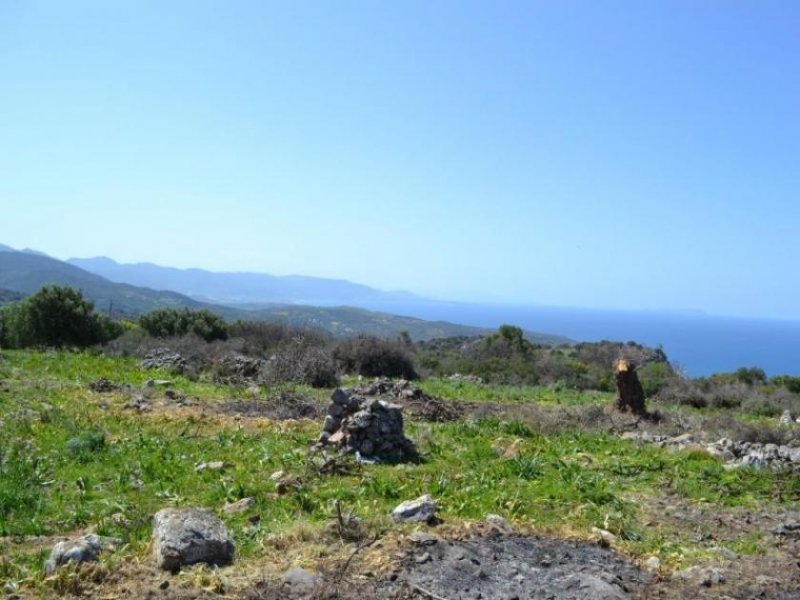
[622,431,800,469]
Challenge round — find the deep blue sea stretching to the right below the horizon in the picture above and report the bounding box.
[368,302,800,377]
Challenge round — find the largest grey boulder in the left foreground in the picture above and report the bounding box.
[153,508,235,571]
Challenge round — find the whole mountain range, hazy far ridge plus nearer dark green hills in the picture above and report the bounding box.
[0,244,568,343]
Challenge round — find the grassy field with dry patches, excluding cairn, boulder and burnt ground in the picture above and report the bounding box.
[0,351,800,598]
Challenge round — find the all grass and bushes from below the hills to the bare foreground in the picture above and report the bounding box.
[0,286,800,596]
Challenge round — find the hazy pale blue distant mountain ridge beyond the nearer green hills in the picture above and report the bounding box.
[67,257,415,306]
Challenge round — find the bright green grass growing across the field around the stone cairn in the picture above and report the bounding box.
[0,351,800,592]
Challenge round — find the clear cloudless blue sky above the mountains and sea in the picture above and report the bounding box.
[0,0,800,319]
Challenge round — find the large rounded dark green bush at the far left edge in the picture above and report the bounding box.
[0,285,122,348]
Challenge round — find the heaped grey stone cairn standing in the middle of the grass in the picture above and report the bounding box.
[319,388,417,463]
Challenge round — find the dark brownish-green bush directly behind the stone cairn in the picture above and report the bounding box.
[333,336,418,379]
